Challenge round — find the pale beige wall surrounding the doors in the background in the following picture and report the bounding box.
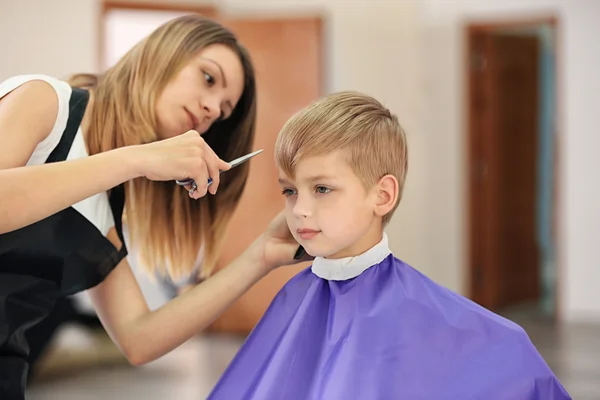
[0,0,600,319]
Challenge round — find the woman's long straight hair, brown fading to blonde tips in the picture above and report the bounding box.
[69,15,256,278]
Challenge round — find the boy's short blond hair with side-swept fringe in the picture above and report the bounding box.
[275,91,408,224]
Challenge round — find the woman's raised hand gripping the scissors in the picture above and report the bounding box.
[134,131,231,199]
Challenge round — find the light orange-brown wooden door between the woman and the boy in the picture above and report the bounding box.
[211,17,322,334]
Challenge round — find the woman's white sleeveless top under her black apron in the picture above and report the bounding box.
[0,75,115,236]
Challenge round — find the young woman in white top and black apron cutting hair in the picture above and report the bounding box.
[0,16,308,399]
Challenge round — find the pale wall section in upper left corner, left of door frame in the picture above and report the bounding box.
[0,0,101,80]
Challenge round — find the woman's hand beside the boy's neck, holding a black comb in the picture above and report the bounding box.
[249,211,314,274]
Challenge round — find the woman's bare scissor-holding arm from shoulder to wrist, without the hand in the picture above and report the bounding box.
[0,81,138,234]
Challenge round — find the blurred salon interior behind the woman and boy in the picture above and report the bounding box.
[0,0,600,400]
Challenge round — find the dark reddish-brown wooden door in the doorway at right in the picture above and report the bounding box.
[469,32,540,309]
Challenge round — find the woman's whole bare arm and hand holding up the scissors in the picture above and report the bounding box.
[0,81,230,234]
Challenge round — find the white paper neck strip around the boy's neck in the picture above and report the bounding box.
[311,232,392,281]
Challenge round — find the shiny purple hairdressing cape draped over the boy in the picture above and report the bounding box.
[209,254,571,400]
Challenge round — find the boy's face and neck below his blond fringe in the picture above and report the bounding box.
[279,151,382,258]
